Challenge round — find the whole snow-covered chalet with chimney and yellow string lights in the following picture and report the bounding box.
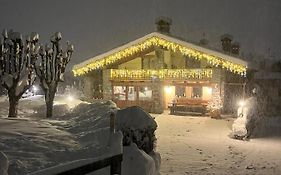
[72,19,247,113]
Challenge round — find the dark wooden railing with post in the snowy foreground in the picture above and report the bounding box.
[29,113,123,175]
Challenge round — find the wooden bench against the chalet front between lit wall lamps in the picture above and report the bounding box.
[169,97,208,114]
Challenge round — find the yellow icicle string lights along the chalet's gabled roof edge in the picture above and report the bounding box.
[72,36,247,76]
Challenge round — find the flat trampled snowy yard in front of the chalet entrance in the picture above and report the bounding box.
[153,112,281,175]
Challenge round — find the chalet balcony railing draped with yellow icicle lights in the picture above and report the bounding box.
[110,69,213,80]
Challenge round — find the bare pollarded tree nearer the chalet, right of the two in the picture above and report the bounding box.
[35,32,73,118]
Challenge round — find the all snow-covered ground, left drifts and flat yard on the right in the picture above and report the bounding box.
[0,96,281,175]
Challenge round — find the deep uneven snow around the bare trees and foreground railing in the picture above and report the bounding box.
[0,96,159,175]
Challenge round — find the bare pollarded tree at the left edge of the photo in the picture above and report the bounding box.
[0,30,40,117]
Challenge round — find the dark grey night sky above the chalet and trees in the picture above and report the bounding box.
[0,0,281,66]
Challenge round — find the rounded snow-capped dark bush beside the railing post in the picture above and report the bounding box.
[116,106,157,154]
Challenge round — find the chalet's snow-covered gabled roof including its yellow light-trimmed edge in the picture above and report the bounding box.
[72,32,248,76]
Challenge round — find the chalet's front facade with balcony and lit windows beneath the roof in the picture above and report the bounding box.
[73,32,244,113]
